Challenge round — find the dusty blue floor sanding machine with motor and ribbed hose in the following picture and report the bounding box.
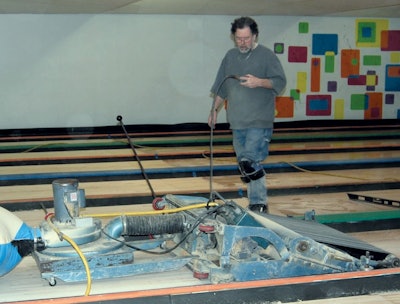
[0,179,399,292]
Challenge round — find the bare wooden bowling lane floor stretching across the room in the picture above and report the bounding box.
[0,124,400,303]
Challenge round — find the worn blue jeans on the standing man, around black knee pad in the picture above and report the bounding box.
[232,128,272,205]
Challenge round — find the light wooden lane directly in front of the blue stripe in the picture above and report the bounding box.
[0,168,399,202]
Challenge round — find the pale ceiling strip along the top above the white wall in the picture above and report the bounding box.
[0,0,400,18]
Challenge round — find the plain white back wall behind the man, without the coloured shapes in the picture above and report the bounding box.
[0,15,399,129]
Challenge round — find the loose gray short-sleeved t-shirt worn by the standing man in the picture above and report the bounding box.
[211,45,286,129]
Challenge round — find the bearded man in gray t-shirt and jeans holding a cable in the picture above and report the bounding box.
[208,17,286,213]
